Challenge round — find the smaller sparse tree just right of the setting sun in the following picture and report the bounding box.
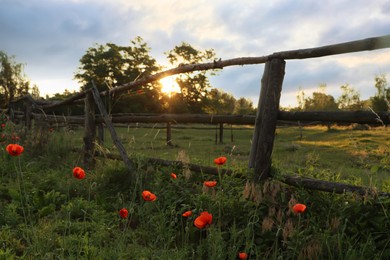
[166,42,216,113]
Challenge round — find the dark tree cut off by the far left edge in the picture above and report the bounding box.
[0,51,30,108]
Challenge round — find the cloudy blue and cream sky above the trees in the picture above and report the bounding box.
[0,0,390,107]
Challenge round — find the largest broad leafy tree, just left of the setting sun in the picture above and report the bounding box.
[75,37,161,112]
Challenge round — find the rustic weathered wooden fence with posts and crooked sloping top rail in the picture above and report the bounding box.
[6,35,390,197]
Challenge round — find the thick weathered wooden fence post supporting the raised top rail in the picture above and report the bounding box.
[249,59,286,182]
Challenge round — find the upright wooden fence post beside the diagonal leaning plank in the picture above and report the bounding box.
[83,92,96,168]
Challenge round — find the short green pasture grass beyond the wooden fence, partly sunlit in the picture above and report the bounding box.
[101,125,390,192]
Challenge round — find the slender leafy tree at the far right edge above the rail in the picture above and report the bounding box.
[370,74,390,111]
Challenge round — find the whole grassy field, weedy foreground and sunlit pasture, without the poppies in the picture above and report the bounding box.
[0,123,390,259]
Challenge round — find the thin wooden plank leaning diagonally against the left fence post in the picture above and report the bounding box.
[91,82,135,177]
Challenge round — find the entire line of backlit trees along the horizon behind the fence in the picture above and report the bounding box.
[0,37,390,115]
